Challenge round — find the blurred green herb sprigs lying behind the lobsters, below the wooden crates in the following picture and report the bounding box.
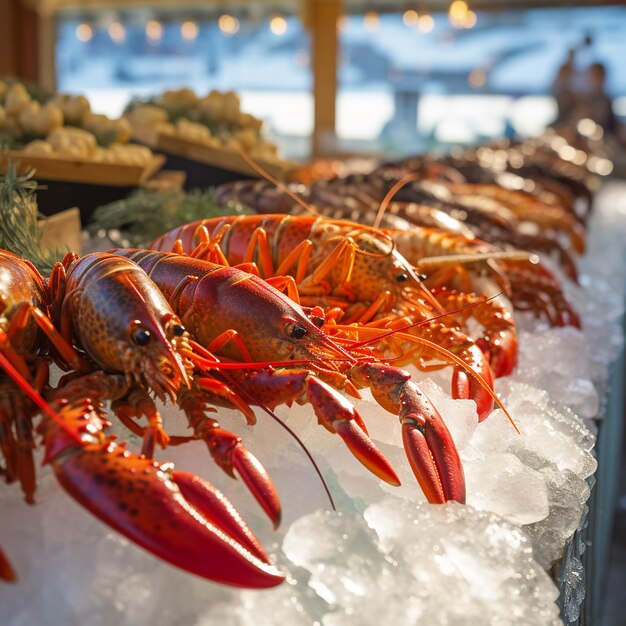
[87,189,252,248]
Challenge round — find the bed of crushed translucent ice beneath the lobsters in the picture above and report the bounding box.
[0,184,626,626]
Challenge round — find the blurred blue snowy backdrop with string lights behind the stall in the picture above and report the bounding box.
[0,0,626,158]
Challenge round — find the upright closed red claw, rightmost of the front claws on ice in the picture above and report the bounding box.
[353,363,465,503]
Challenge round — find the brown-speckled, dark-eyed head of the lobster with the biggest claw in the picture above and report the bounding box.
[67,254,192,401]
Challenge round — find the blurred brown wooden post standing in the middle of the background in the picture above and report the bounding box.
[305,0,341,156]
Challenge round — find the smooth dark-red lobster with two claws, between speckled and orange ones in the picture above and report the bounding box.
[115,249,465,502]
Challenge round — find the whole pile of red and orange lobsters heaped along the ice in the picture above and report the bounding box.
[0,129,590,588]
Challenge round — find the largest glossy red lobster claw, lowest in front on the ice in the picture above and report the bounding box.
[51,441,284,588]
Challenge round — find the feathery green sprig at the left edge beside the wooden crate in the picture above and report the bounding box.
[0,163,64,274]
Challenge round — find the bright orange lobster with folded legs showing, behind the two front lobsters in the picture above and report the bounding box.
[149,215,500,419]
